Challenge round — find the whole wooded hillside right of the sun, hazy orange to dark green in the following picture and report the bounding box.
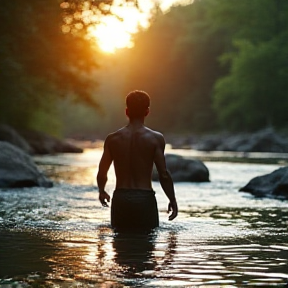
[127,0,288,132]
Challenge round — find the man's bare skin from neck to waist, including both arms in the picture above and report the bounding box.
[97,113,178,220]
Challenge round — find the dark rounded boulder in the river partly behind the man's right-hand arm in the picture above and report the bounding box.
[152,154,209,182]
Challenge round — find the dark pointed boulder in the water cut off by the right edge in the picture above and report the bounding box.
[239,166,288,199]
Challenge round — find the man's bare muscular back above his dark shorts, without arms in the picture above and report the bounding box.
[107,124,164,190]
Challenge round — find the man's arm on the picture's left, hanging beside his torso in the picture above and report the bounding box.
[97,137,113,207]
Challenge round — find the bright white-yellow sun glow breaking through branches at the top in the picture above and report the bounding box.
[61,0,193,53]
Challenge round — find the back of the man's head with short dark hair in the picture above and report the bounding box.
[126,90,150,119]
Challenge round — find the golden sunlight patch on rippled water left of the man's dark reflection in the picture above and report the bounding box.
[48,226,119,283]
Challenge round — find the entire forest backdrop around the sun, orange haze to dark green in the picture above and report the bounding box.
[0,0,288,137]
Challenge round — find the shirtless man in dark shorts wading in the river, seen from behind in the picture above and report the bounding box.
[97,90,178,230]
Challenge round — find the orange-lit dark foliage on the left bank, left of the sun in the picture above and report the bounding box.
[0,0,97,132]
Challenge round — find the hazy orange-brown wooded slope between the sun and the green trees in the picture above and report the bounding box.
[122,0,226,132]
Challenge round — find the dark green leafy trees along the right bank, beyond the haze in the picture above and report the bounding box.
[213,0,288,130]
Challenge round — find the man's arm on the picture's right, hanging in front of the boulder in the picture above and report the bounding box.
[154,134,178,220]
